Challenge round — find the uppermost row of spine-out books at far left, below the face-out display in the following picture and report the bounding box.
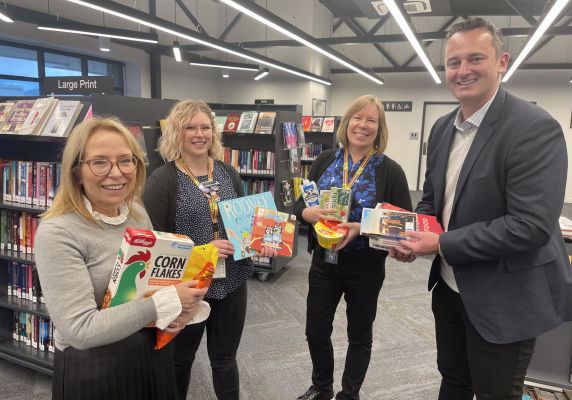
[0,160,61,209]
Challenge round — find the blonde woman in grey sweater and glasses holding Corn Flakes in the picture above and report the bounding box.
[35,118,206,400]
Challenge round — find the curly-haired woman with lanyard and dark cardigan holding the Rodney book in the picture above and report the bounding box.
[143,100,264,400]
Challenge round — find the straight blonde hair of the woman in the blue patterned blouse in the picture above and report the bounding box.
[336,94,389,154]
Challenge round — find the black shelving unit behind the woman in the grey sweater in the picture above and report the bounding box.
[0,94,176,375]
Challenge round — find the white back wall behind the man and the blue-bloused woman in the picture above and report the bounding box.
[332,71,572,202]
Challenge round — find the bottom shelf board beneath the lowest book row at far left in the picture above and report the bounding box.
[0,338,54,376]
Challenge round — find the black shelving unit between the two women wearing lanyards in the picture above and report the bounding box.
[210,104,302,280]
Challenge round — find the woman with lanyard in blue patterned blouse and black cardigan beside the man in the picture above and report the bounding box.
[295,95,412,400]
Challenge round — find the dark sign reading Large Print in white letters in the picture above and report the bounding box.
[41,76,113,96]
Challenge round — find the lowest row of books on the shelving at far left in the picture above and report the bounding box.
[12,311,54,353]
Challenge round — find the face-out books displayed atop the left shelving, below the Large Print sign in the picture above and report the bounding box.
[0,97,86,137]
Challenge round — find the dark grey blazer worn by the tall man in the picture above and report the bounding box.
[416,88,572,343]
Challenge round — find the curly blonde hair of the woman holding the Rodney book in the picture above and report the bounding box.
[158,100,223,161]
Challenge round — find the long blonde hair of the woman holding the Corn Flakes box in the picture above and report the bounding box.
[41,117,145,223]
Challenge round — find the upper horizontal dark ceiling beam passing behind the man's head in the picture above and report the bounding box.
[180,26,572,51]
